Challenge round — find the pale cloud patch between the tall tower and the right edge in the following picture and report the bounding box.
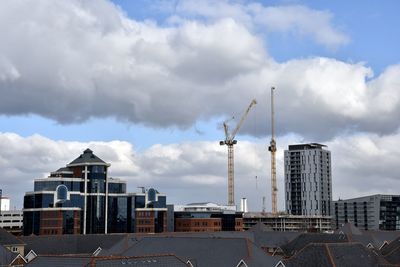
[327,132,400,198]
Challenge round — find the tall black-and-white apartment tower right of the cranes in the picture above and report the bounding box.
[284,143,332,216]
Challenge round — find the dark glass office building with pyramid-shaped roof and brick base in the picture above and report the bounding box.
[23,149,167,235]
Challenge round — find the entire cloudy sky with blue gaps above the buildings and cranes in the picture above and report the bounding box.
[0,0,400,210]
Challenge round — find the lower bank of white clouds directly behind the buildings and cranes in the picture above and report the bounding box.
[0,133,400,213]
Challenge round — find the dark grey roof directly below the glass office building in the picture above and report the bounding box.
[21,234,125,255]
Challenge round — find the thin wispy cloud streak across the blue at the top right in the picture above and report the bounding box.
[170,0,350,48]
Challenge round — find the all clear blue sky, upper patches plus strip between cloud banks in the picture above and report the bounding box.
[0,0,400,148]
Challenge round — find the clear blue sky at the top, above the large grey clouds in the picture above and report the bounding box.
[113,0,400,74]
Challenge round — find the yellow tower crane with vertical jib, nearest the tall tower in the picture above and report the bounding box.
[268,87,278,215]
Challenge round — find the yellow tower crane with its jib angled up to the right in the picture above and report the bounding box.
[219,99,257,206]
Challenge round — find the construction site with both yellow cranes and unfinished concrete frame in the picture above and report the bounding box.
[220,87,332,232]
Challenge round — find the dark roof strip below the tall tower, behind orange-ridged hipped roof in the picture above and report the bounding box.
[281,233,348,256]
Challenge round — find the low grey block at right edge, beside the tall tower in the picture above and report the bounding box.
[333,195,400,230]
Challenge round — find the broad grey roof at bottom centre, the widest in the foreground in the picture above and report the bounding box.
[122,237,279,267]
